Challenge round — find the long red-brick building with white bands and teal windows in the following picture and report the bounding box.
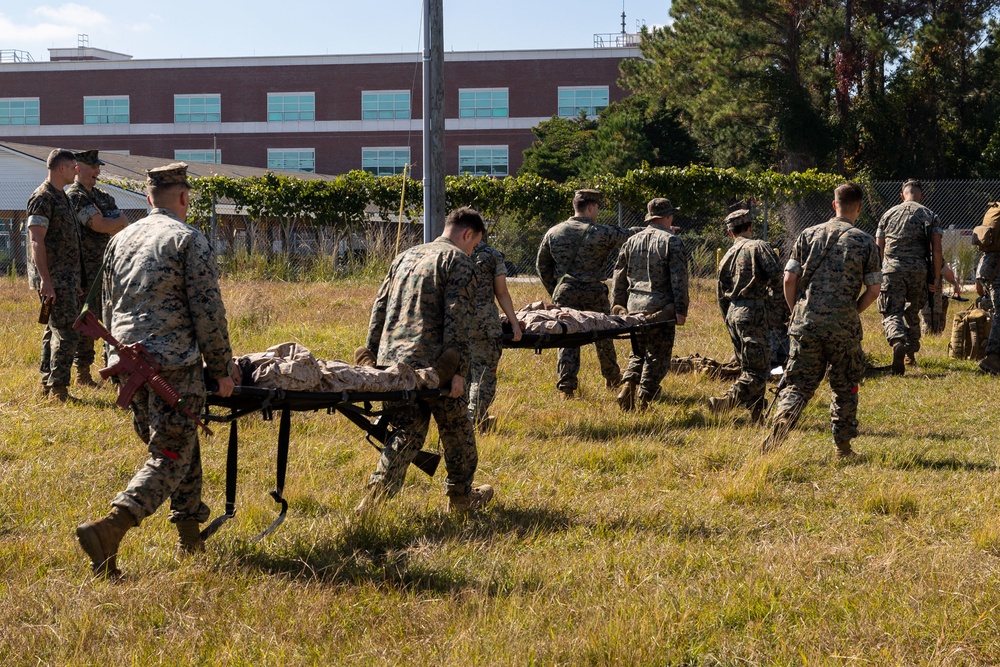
[0,46,639,178]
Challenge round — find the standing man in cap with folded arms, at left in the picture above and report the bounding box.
[66,150,126,386]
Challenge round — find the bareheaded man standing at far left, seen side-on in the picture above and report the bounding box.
[26,149,81,401]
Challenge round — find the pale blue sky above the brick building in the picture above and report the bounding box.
[0,0,670,61]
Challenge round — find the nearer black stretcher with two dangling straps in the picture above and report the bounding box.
[201,386,445,542]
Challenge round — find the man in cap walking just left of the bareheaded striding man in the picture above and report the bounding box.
[709,209,782,418]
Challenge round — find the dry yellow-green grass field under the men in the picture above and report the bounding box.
[0,280,1000,665]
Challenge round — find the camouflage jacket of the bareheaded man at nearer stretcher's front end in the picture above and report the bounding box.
[365,236,475,378]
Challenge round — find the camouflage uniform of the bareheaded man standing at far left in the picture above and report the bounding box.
[27,181,81,387]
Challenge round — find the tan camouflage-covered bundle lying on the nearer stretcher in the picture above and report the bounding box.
[236,343,440,393]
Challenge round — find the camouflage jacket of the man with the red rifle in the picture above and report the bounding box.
[104,208,233,378]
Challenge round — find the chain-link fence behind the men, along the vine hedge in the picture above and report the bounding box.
[0,180,1000,280]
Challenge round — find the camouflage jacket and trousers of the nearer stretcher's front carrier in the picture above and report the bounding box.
[365,236,479,496]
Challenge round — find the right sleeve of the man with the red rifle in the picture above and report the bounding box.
[184,234,233,378]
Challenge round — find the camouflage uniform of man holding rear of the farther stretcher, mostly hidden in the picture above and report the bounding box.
[468,241,507,424]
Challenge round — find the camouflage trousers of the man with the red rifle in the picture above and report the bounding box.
[111,366,210,523]
